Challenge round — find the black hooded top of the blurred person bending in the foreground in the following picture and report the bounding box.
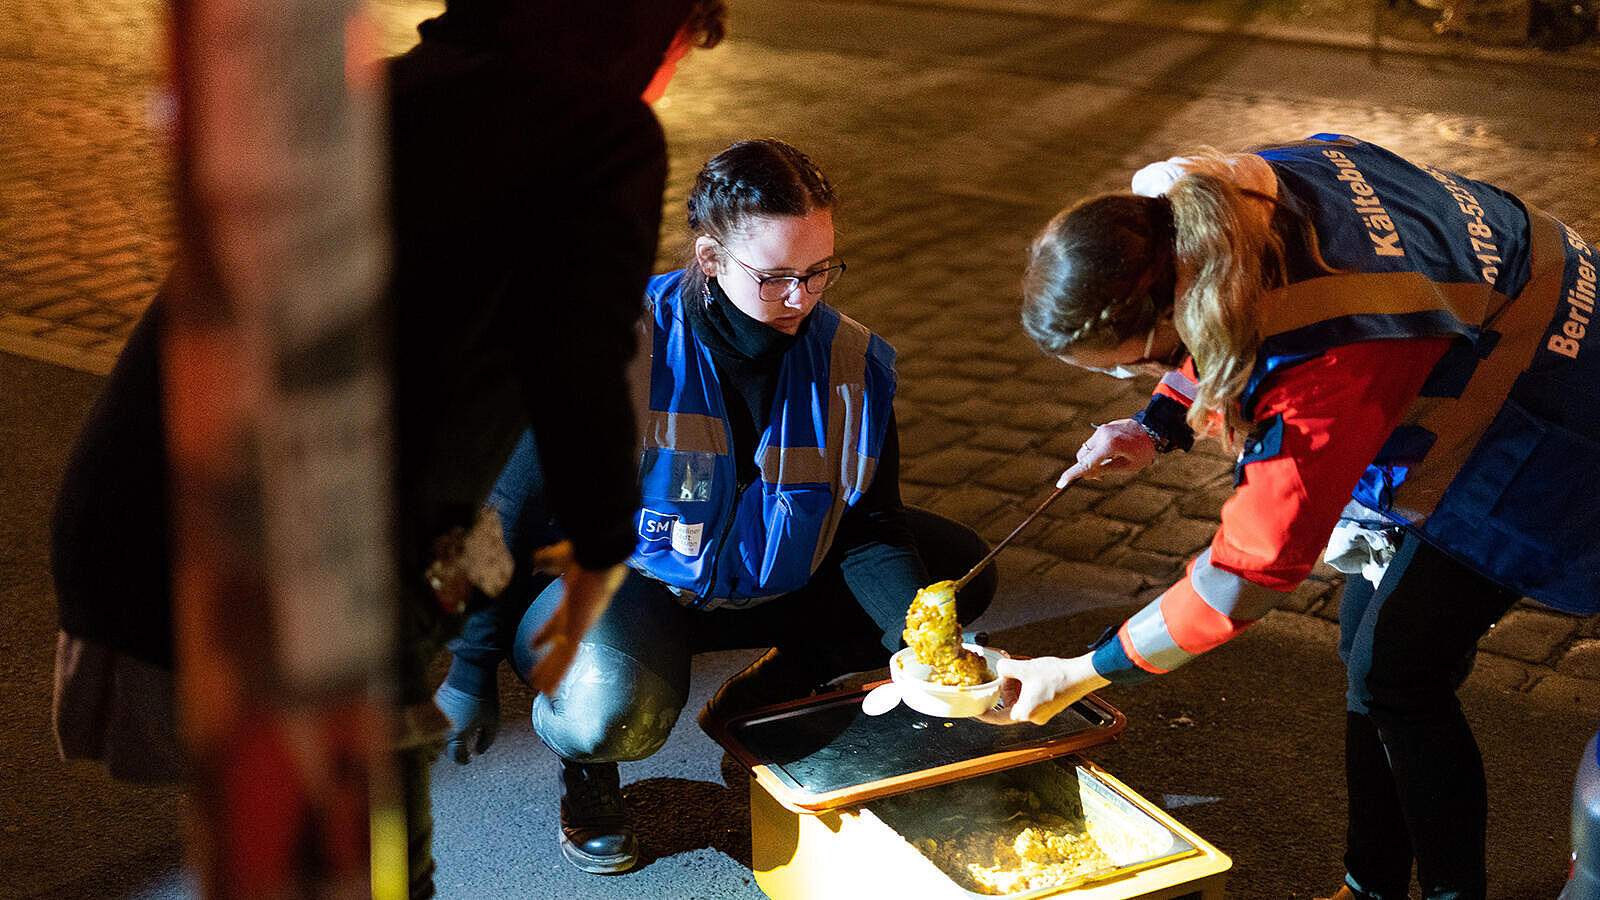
[390,0,690,608]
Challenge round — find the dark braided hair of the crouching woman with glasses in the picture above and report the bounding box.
[683,138,838,296]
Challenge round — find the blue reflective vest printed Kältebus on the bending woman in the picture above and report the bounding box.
[1240,135,1600,613]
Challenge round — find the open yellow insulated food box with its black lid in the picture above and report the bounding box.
[712,685,1232,900]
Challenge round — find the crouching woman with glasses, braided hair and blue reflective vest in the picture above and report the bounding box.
[437,141,995,873]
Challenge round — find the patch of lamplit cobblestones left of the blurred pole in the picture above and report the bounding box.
[0,0,173,372]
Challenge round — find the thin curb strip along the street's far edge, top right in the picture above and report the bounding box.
[838,0,1600,72]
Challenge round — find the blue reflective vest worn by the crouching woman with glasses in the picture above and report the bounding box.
[629,271,894,607]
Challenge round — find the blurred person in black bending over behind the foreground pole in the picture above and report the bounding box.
[51,0,725,897]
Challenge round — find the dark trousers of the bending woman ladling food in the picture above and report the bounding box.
[1339,533,1518,900]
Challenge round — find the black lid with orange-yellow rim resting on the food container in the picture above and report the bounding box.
[700,684,1126,812]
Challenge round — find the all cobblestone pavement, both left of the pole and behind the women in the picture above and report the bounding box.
[9,0,1600,709]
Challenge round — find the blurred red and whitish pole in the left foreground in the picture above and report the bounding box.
[163,0,405,897]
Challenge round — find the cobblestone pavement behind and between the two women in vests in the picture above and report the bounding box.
[662,5,1600,708]
